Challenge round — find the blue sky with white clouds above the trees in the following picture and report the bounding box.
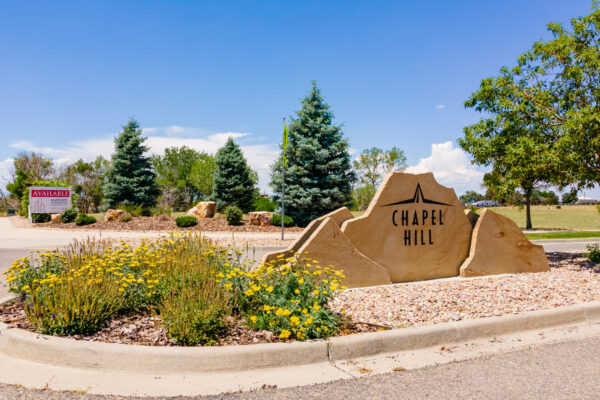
[0,0,600,197]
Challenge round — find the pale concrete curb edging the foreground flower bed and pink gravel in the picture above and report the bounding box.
[0,302,600,374]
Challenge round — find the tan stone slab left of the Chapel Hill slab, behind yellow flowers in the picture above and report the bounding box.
[298,218,391,287]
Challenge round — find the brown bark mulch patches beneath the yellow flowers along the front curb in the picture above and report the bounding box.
[0,299,385,346]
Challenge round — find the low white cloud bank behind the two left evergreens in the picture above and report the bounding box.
[7,125,279,192]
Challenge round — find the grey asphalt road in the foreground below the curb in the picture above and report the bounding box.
[0,336,600,400]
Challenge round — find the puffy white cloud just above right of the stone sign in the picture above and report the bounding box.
[405,142,483,196]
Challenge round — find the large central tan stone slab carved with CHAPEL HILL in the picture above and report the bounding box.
[342,172,473,282]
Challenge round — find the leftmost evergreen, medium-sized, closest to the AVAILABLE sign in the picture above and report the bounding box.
[103,119,160,209]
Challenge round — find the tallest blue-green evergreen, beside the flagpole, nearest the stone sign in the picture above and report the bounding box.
[271,81,356,226]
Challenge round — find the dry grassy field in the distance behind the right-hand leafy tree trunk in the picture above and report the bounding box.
[490,206,600,230]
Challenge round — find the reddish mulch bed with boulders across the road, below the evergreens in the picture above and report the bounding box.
[29,215,302,232]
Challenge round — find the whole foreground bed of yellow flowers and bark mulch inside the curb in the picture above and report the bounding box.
[0,233,376,346]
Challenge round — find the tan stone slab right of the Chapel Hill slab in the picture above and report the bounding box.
[460,209,550,276]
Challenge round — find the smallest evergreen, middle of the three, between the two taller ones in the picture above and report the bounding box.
[211,138,255,212]
